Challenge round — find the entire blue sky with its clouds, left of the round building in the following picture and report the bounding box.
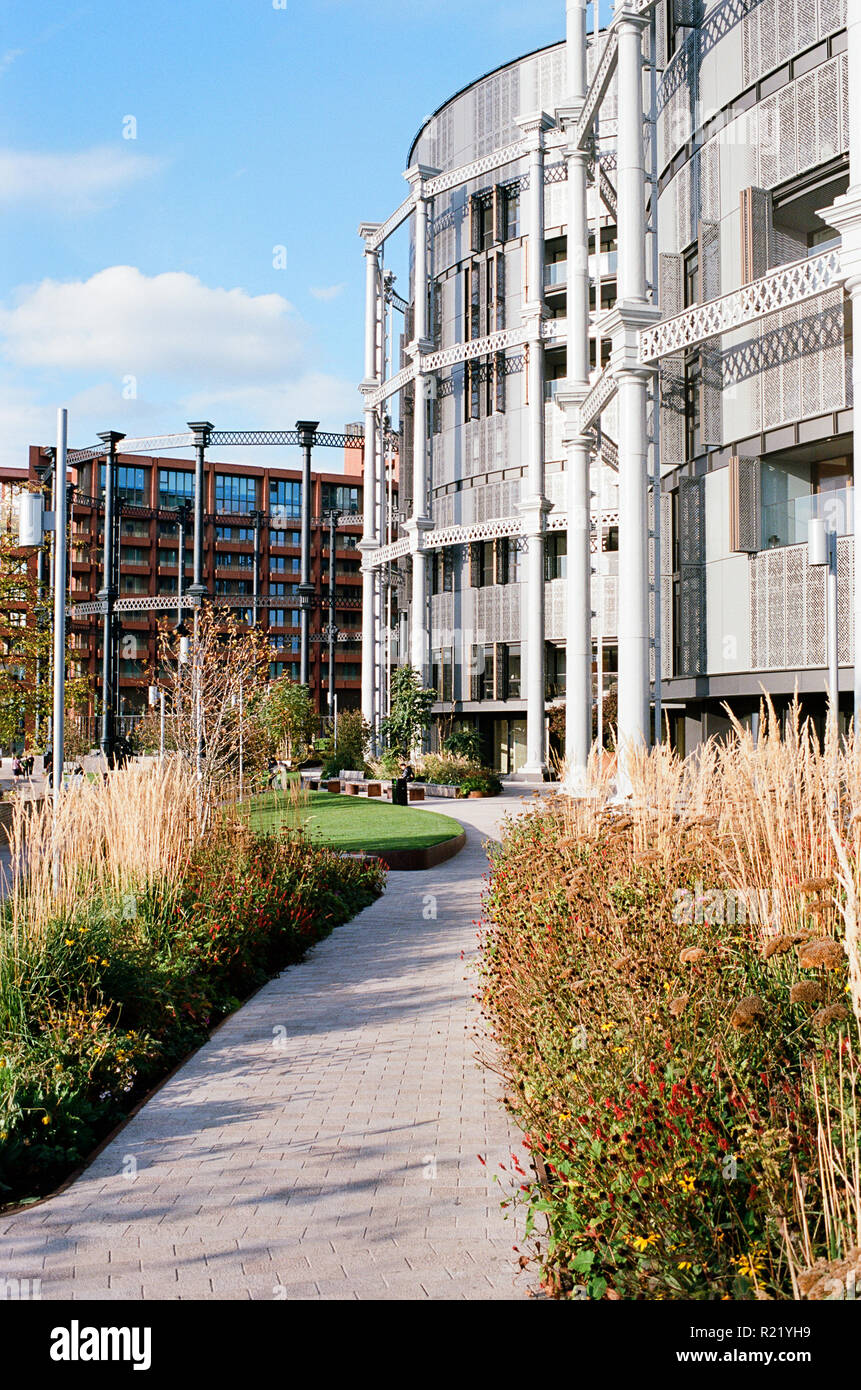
[0,0,606,464]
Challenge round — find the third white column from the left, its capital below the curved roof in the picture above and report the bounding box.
[517,111,552,777]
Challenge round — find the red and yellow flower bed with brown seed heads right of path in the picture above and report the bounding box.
[483,760,861,1300]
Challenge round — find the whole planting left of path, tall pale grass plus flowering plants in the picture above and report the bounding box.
[0,760,384,1205]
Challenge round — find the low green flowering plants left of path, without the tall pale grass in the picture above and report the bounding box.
[0,828,384,1202]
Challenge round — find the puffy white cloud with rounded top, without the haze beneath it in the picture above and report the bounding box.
[0,265,306,389]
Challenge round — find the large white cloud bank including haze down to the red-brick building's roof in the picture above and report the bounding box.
[0,265,362,467]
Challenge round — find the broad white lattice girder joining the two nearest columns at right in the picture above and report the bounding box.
[638,250,846,363]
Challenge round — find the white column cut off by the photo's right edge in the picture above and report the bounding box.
[819,0,861,731]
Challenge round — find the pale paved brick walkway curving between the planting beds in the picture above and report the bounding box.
[0,791,545,1300]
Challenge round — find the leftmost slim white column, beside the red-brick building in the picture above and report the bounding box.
[359,222,380,728]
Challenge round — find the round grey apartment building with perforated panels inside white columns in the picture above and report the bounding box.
[360,0,861,777]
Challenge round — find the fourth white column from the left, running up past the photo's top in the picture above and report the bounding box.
[556,0,593,792]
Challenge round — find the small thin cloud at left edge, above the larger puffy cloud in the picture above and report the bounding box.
[0,148,161,213]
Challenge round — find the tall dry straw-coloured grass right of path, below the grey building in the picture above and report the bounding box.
[554,696,861,1027]
